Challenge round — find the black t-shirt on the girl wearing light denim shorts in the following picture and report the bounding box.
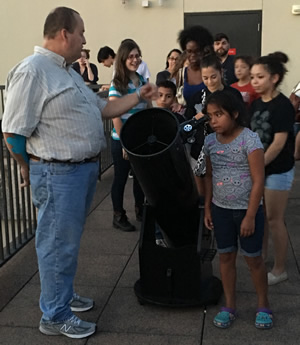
[250,93,295,175]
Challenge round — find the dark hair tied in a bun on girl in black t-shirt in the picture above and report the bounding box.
[254,52,289,87]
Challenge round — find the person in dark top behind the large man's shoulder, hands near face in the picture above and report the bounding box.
[72,49,98,85]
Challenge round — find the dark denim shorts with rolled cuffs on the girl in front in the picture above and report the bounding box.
[212,205,264,257]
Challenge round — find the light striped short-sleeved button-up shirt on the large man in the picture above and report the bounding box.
[2,47,106,162]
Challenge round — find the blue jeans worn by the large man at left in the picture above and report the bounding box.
[30,161,99,321]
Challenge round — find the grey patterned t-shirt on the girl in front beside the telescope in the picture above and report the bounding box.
[204,128,263,209]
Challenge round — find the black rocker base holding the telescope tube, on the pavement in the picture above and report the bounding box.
[134,205,223,307]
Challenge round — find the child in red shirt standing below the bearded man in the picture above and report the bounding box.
[231,56,259,107]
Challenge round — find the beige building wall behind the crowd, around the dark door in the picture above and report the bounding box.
[0,0,300,93]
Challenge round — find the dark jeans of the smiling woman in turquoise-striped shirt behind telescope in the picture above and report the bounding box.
[111,139,145,213]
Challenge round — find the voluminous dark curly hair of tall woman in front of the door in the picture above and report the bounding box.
[178,25,214,55]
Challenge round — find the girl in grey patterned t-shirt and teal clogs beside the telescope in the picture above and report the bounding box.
[204,91,273,329]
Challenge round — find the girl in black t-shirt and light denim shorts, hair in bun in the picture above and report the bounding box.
[250,52,295,285]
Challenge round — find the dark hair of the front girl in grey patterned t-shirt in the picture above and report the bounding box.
[203,89,248,127]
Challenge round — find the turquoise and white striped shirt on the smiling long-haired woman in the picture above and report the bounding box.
[108,75,147,140]
